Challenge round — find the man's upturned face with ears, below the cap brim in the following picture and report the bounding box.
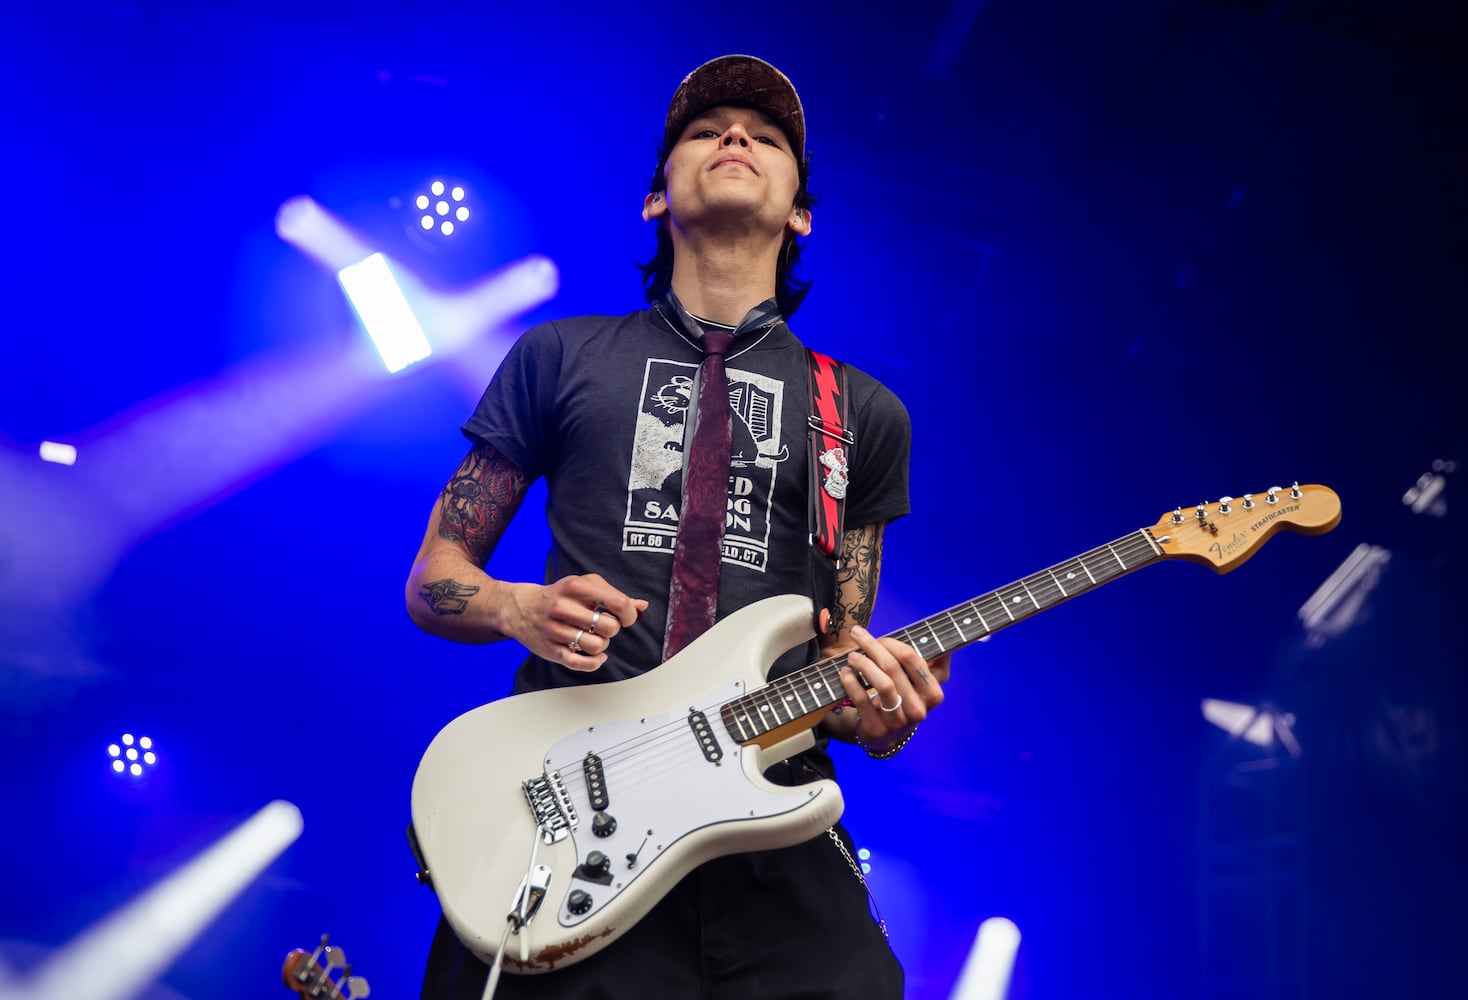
[643,106,809,235]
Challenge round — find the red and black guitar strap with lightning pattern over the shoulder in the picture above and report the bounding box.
[806,349,856,631]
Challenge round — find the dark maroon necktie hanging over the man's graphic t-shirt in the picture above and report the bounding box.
[662,330,734,659]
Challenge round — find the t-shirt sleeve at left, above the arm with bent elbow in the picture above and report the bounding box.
[462,323,564,480]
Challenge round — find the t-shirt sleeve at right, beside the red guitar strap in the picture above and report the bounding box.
[846,382,912,530]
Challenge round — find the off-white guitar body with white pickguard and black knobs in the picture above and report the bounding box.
[413,596,843,972]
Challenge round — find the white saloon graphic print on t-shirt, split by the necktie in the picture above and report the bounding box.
[622,358,790,573]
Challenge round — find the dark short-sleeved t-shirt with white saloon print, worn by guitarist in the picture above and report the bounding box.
[464,310,912,690]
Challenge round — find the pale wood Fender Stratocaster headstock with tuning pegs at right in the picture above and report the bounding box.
[1151,483,1340,573]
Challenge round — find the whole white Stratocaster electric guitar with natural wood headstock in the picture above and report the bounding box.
[413,486,1340,974]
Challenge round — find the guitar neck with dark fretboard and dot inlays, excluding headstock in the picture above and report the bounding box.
[721,527,1163,743]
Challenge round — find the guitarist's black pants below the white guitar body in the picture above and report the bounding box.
[423,827,903,1000]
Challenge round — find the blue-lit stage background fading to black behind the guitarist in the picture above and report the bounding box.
[0,0,1468,1000]
